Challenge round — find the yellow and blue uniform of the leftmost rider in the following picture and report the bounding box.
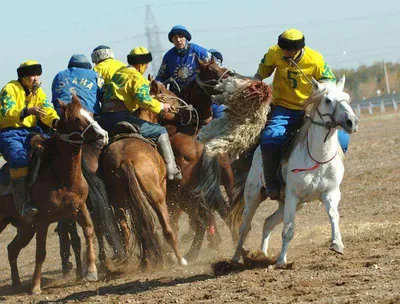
[0,80,59,178]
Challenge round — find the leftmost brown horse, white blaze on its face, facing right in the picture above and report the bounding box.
[0,97,108,294]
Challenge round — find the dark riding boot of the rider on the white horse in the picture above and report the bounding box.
[261,148,281,200]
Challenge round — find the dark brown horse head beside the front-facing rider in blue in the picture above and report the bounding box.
[190,59,234,121]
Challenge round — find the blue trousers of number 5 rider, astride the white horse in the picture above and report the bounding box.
[260,106,350,152]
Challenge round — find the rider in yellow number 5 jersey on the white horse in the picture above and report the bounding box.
[254,28,348,199]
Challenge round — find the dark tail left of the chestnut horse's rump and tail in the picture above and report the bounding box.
[82,160,124,259]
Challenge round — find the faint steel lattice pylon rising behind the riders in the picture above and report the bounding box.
[145,5,164,77]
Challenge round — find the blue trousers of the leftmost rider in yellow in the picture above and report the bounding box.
[0,126,43,169]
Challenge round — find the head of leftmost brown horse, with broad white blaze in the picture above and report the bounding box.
[57,95,108,149]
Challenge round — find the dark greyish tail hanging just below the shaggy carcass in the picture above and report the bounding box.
[195,152,227,215]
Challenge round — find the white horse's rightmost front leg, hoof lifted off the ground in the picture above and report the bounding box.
[321,189,344,254]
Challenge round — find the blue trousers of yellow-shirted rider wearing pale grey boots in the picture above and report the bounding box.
[99,111,167,141]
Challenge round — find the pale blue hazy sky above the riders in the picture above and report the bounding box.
[0,0,400,98]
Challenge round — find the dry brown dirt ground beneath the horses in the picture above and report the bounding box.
[0,112,400,304]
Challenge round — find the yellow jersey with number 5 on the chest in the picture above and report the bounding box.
[257,45,336,110]
